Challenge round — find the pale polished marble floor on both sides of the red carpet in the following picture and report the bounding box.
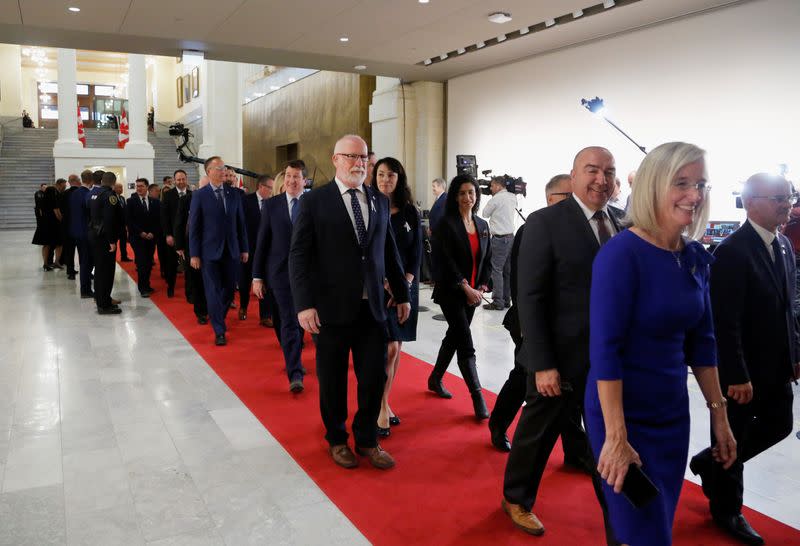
[0,227,800,546]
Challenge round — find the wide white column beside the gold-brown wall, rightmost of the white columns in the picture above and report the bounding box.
[198,61,241,176]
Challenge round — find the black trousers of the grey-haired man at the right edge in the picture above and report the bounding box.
[696,383,794,516]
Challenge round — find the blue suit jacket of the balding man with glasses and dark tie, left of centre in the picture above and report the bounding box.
[189,184,249,260]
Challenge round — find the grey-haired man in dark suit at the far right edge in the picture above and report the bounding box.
[689,173,800,544]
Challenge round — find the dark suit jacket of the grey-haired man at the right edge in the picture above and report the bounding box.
[711,221,800,386]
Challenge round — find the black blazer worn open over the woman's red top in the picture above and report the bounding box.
[431,214,492,303]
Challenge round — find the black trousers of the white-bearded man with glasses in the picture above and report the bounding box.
[316,300,386,448]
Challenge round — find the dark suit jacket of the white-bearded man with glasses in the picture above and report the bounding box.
[289,181,408,325]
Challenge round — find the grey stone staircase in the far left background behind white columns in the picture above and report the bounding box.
[0,126,192,229]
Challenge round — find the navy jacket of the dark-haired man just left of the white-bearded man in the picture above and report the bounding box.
[253,194,302,290]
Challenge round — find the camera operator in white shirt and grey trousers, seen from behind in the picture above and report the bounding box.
[483,176,517,311]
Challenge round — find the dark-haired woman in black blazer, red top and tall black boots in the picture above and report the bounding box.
[428,175,492,419]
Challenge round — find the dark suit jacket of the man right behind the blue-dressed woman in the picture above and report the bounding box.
[516,195,620,381]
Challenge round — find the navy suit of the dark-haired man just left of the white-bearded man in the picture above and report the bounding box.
[253,194,303,381]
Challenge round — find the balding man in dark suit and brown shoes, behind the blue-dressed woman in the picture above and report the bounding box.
[502,147,619,542]
